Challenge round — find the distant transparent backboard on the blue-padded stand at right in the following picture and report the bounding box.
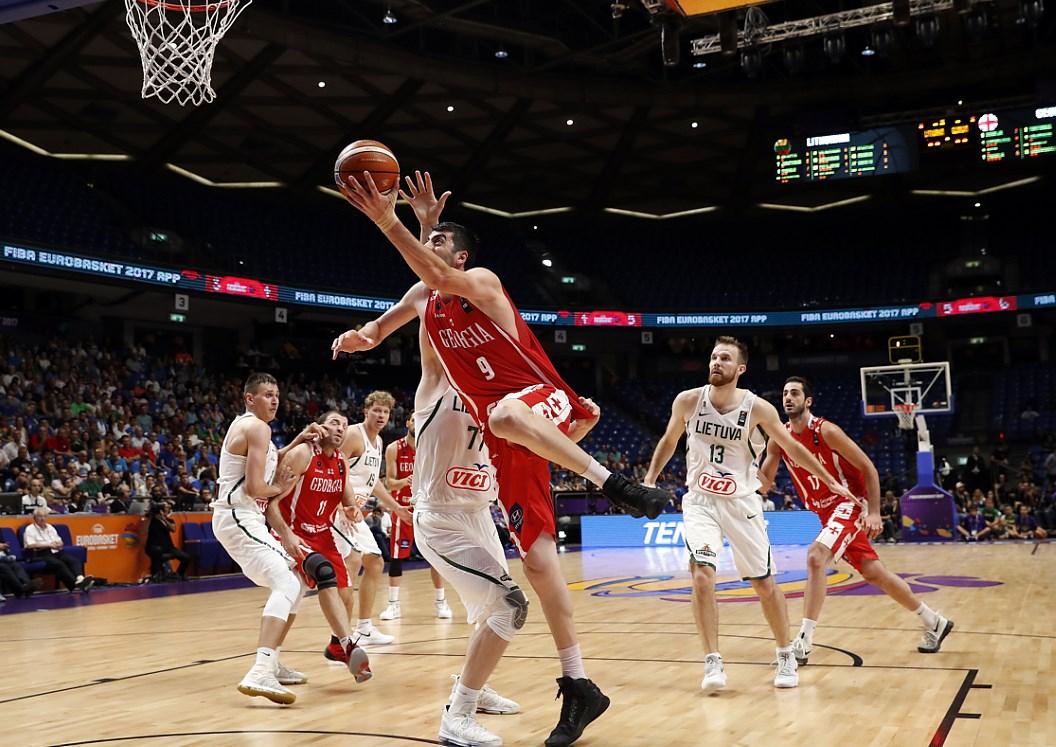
[861,361,954,417]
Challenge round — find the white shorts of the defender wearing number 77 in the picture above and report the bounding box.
[414,506,517,624]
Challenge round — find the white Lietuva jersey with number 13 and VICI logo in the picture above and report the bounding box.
[685,385,767,498]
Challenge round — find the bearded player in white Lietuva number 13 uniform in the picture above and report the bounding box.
[644,336,853,691]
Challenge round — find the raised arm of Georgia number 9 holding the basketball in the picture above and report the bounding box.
[341,171,503,305]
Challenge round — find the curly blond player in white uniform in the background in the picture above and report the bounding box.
[324,392,411,660]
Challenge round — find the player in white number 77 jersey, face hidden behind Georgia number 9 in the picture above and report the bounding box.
[414,323,519,746]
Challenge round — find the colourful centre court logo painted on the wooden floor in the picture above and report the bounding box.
[568,568,1002,602]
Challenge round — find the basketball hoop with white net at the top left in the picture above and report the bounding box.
[125,0,252,106]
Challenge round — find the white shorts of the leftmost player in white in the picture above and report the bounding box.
[212,507,300,589]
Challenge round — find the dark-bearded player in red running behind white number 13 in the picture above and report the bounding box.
[759,376,954,665]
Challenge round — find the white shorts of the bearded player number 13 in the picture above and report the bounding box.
[682,492,777,581]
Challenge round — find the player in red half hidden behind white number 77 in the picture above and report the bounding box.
[380,412,453,620]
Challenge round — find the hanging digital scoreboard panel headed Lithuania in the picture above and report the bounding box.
[774,127,917,184]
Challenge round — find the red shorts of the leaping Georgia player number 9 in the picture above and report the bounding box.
[485,384,572,555]
